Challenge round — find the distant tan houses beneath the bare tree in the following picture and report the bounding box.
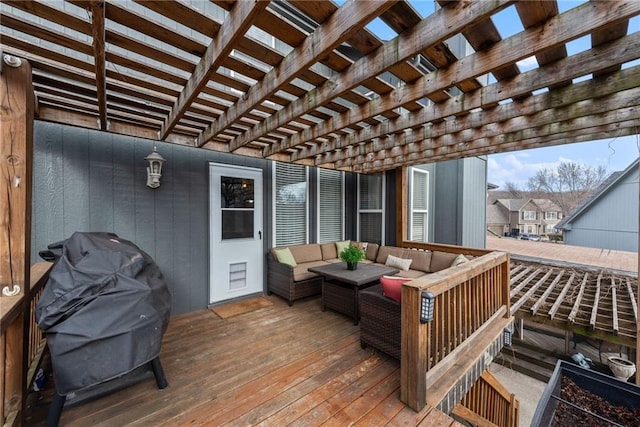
[487,199,562,235]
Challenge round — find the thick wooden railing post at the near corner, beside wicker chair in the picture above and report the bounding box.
[400,284,430,411]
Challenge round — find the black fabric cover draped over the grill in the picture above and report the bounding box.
[36,233,171,395]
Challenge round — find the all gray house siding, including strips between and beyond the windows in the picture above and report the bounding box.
[31,121,486,315]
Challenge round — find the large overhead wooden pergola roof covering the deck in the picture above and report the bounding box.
[1,0,640,173]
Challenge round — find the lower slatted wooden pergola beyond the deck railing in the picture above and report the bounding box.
[510,259,638,348]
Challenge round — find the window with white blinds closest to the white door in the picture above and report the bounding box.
[273,163,307,246]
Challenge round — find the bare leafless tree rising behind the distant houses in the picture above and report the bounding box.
[528,162,607,215]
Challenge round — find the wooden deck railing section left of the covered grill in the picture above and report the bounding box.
[0,263,52,426]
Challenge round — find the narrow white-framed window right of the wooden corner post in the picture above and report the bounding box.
[407,168,429,242]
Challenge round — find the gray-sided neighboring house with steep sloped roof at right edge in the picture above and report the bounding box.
[556,159,639,252]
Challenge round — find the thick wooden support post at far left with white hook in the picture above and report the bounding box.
[0,53,34,424]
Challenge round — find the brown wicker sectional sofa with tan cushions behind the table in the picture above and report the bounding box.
[267,242,457,305]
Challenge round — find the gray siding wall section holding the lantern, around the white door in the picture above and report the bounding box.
[31,122,271,314]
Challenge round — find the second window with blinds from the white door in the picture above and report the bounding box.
[318,169,344,243]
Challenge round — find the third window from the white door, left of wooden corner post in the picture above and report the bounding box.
[358,174,384,244]
